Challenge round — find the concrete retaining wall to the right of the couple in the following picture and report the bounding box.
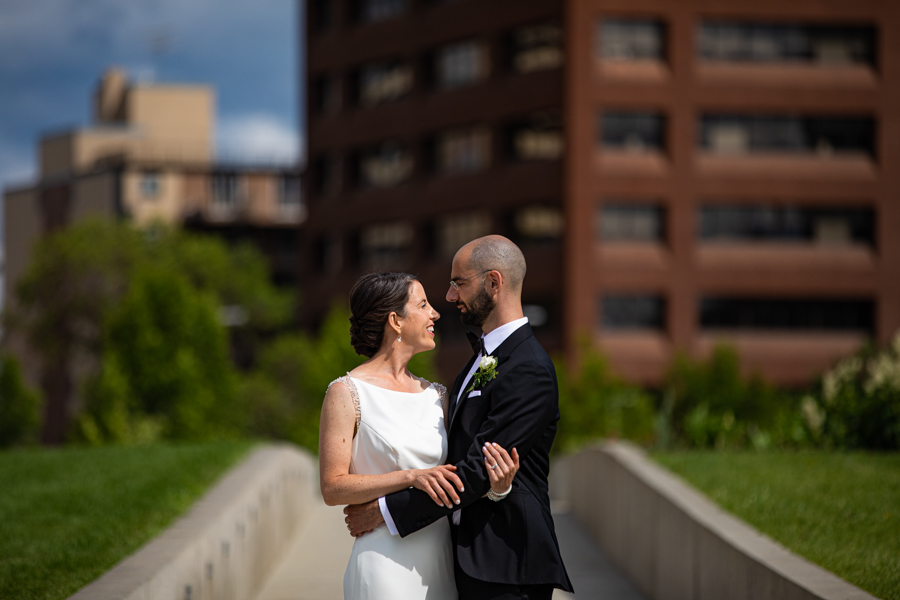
[551,442,875,600]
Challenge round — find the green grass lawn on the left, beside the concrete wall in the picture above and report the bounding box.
[0,442,251,600]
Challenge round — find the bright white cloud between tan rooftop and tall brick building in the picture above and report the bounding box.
[216,113,300,164]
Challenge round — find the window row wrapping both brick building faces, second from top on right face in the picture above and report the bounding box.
[312,110,875,193]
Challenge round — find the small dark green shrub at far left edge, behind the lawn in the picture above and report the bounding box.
[0,356,41,448]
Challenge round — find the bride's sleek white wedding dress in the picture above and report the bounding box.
[332,375,458,600]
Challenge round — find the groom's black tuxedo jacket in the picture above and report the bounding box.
[385,324,572,592]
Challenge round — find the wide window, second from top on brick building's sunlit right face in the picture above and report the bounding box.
[699,115,875,155]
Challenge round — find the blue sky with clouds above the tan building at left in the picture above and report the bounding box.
[0,0,302,188]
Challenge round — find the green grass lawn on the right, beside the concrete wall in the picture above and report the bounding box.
[653,451,900,600]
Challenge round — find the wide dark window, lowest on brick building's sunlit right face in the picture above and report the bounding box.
[700,297,875,333]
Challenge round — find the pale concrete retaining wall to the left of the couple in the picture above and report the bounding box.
[69,445,321,600]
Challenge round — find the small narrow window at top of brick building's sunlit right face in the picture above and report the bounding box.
[596,19,666,61]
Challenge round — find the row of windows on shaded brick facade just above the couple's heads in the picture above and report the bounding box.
[315,205,564,273]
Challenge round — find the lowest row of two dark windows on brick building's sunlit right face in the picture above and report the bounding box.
[600,294,875,333]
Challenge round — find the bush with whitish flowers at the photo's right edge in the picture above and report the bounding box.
[802,332,900,450]
